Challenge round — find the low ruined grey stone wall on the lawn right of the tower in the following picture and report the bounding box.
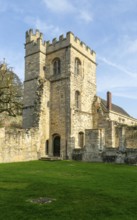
[72,127,137,164]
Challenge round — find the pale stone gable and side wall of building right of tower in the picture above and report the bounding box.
[93,97,137,150]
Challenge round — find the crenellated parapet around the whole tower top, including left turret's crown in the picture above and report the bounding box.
[26,29,96,62]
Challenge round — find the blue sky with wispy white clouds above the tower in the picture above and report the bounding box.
[0,0,137,118]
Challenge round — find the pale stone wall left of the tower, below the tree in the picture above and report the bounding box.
[0,128,40,163]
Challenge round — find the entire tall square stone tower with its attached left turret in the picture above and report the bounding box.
[23,31,96,158]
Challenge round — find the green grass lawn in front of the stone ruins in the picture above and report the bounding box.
[0,161,137,220]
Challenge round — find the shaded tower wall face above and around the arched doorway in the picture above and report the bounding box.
[45,44,70,158]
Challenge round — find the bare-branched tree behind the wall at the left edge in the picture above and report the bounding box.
[0,62,23,116]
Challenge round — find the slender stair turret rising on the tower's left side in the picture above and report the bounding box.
[23,29,46,128]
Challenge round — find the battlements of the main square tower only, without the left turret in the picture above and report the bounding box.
[46,32,96,61]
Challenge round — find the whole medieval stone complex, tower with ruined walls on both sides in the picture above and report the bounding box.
[0,30,137,163]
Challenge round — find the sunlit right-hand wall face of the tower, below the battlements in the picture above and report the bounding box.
[70,47,96,148]
